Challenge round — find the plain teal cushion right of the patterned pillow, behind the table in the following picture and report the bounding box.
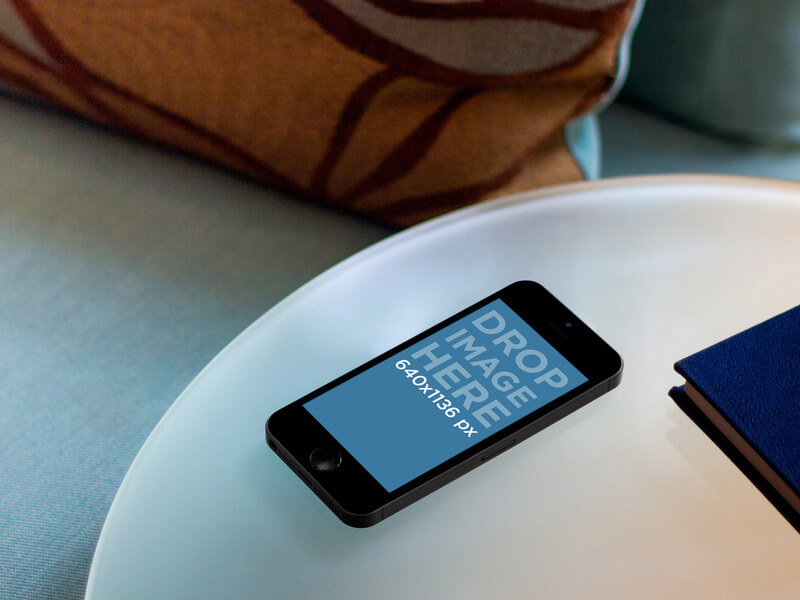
[625,0,800,144]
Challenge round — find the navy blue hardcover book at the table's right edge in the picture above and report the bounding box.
[670,306,800,532]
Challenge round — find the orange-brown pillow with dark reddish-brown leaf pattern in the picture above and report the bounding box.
[0,0,634,225]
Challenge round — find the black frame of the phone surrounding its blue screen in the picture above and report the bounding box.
[266,281,622,526]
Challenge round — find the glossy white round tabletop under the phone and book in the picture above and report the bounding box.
[87,176,800,600]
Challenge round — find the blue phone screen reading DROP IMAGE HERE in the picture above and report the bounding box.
[304,300,587,492]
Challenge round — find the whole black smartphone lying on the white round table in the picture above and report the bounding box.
[266,281,622,527]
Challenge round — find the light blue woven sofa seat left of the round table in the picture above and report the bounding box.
[0,95,394,600]
